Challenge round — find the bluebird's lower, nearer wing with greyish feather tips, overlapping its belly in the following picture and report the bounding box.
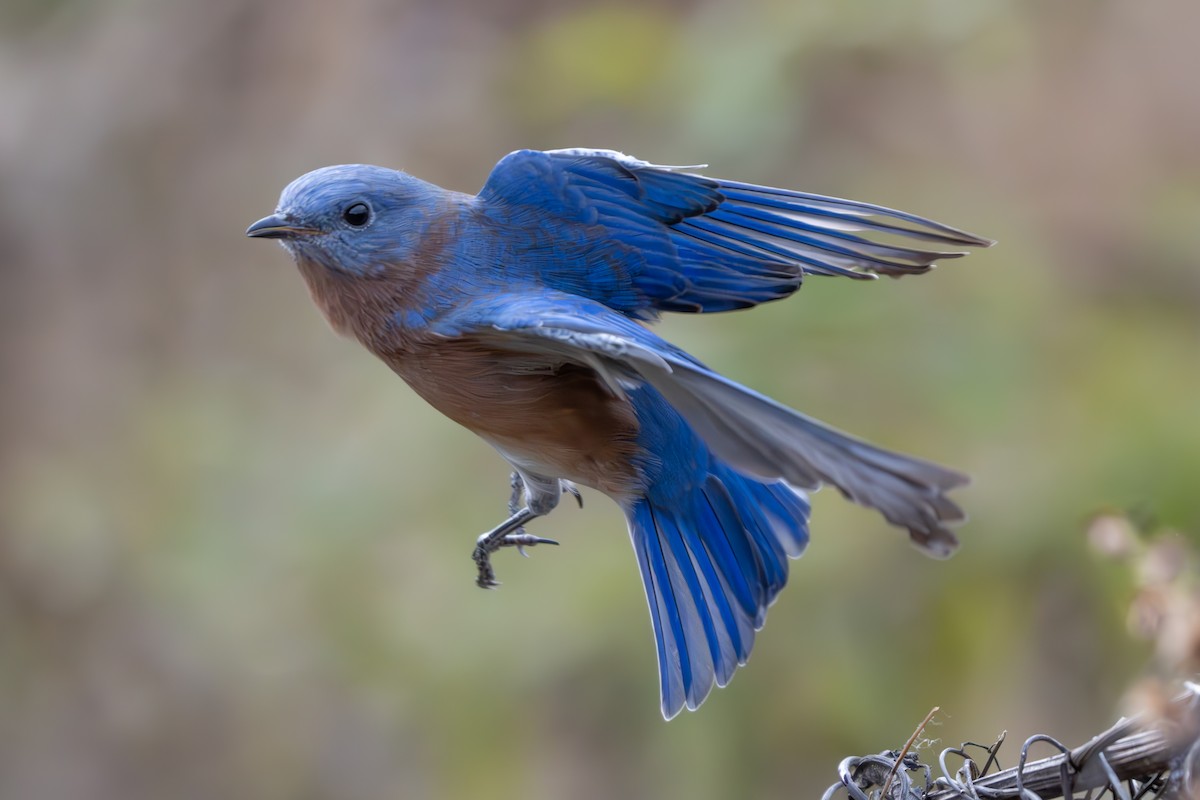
[436,291,967,558]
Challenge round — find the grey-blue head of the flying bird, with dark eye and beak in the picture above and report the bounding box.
[246,164,450,276]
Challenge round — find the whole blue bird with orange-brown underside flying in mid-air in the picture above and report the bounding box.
[246,148,994,720]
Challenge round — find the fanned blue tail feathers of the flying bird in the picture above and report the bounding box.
[628,458,809,720]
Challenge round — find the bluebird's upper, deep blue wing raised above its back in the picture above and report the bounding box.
[479,150,991,319]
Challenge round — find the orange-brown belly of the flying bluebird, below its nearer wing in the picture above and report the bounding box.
[385,338,637,498]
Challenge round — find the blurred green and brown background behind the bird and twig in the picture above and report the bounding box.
[0,0,1200,800]
